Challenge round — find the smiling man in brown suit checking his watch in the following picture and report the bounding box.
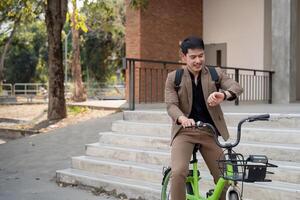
[165,37,243,200]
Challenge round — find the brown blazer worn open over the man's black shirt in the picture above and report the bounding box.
[165,66,243,144]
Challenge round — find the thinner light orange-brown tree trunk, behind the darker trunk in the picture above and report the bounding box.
[71,1,87,102]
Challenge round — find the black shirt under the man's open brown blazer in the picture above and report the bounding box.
[189,71,215,127]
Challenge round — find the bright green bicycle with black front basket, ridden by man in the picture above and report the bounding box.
[161,114,277,200]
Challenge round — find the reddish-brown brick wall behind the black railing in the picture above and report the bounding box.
[126,0,202,102]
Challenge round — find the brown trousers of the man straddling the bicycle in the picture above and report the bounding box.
[171,128,226,200]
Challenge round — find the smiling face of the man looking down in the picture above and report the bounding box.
[183,49,205,74]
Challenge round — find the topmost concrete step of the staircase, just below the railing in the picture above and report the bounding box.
[123,110,300,128]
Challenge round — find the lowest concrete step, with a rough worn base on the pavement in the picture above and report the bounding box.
[56,169,161,200]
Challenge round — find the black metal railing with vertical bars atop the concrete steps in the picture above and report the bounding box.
[123,58,274,110]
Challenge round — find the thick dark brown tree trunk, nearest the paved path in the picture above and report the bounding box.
[45,0,68,120]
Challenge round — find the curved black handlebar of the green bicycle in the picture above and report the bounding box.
[195,114,270,148]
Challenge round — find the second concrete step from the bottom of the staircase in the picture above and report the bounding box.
[72,156,300,186]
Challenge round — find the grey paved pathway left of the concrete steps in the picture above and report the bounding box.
[0,113,122,200]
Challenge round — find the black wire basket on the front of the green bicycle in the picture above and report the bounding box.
[218,152,277,182]
